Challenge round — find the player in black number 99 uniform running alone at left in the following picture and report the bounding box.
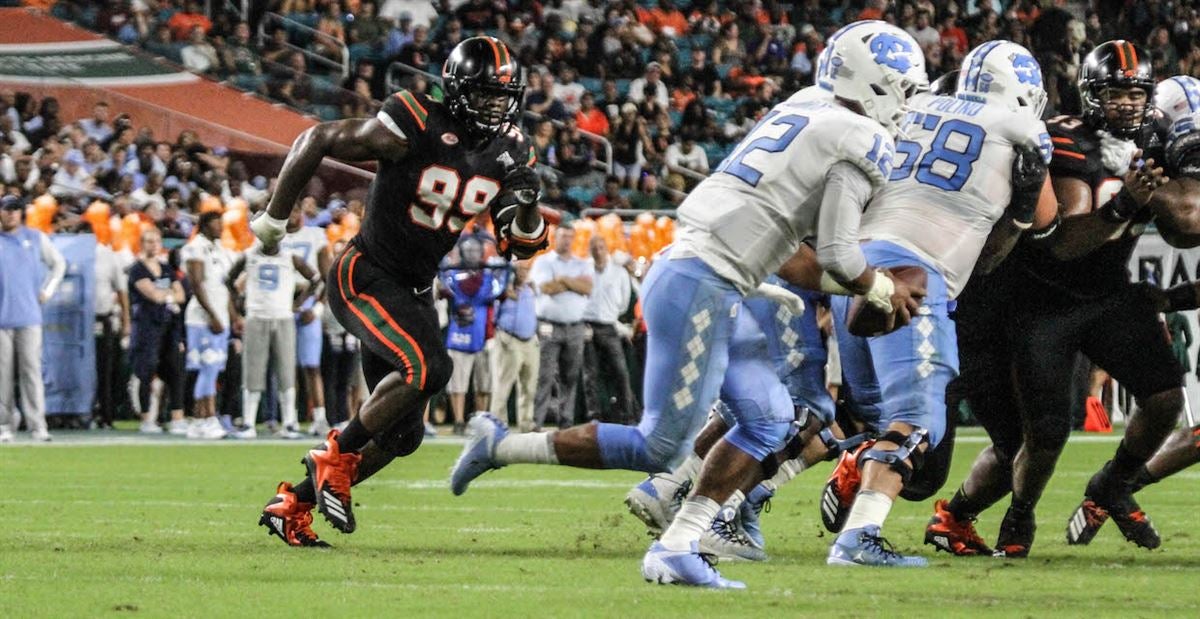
[251,36,546,546]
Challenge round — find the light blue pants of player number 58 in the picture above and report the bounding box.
[832,241,959,447]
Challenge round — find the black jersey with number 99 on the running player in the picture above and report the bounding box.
[353,90,534,287]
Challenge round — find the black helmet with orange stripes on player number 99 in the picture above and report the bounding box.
[442,36,524,137]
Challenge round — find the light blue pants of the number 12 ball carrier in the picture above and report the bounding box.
[596,256,792,473]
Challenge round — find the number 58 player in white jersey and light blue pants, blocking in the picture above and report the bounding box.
[827,41,1054,566]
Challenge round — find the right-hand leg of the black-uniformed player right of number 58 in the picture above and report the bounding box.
[1067,287,1183,548]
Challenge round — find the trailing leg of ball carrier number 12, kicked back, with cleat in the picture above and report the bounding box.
[451,258,740,503]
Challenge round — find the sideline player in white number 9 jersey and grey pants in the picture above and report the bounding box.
[226,242,320,439]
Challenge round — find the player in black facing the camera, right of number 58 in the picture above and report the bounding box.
[926,41,1183,557]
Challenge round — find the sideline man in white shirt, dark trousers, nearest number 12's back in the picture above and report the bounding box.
[583,235,635,423]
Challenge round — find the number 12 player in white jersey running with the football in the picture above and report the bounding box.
[451,22,928,588]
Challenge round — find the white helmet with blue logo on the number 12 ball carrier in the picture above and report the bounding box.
[816,20,929,134]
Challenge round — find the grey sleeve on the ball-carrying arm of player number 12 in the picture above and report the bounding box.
[817,161,872,282]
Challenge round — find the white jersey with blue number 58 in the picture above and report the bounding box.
[859,95,1050,299]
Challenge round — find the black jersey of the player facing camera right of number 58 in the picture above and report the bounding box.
[1007,116,1162,305]
